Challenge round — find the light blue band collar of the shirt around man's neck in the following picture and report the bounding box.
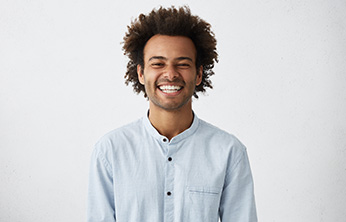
[142,111,199,144]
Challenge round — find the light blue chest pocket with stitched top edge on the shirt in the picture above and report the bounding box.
[187,187,222,222]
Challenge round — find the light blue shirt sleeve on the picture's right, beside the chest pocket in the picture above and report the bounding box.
[219,147,257,222]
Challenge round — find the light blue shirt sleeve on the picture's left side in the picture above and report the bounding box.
[87,149,116,222]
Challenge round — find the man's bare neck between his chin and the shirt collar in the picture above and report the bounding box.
[149,102,193,140]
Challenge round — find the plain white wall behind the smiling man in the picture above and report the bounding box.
[0,0,346,222]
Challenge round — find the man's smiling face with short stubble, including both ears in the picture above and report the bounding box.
[137,35,203,111]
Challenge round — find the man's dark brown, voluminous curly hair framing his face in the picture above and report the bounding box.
[123,6,218,98]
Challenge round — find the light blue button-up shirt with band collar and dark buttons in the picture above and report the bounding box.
[87,115,257,222]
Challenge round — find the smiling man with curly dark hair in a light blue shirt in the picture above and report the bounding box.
[88,7,257,222]
